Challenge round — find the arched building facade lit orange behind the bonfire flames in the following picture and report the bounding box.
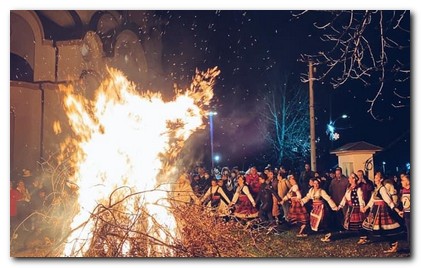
[10,10,168,179]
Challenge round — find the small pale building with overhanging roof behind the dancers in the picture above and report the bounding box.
[330,141,383,180]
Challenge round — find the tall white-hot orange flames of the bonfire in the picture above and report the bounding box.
[55,67,219,256]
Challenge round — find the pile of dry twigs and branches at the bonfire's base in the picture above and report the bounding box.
[65,201,250,257]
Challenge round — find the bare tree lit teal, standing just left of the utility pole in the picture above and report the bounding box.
[261,75,310,163]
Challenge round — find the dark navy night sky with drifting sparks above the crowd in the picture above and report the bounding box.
[153,10,410,173]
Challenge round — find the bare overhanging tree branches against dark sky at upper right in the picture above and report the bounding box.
[293,10,410,120]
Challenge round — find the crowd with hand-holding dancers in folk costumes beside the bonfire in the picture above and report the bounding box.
[169,164,410,253]
